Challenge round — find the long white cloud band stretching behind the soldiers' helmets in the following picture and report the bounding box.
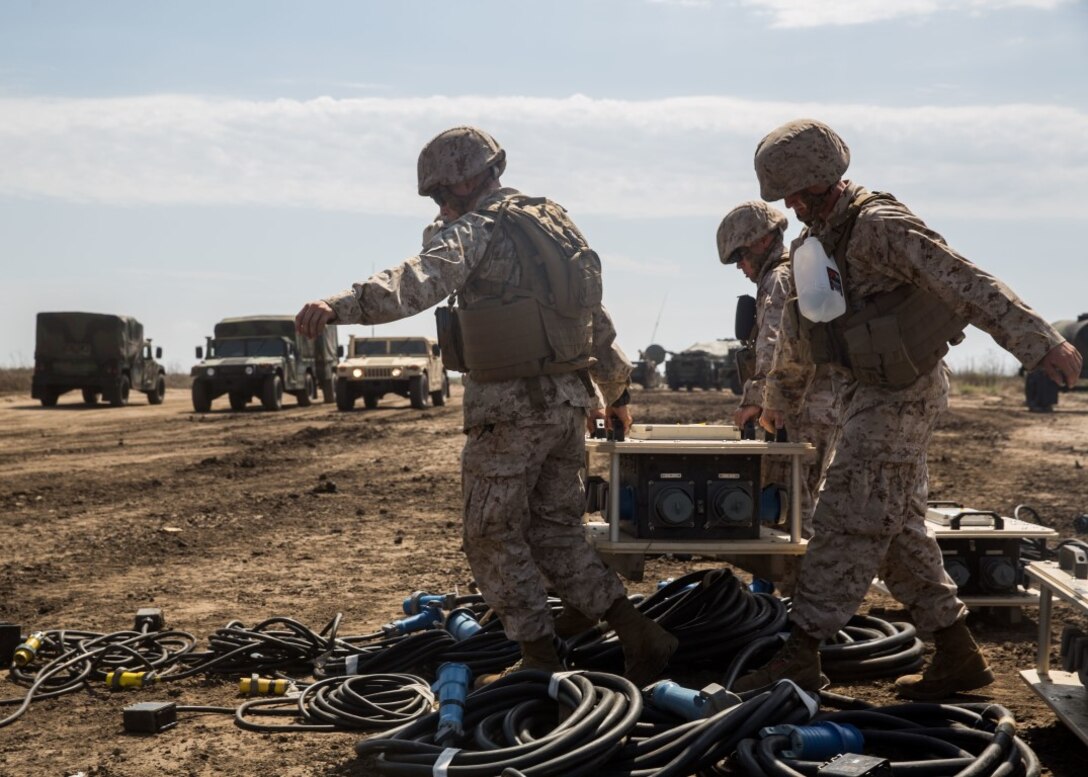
[0,95,1088,218]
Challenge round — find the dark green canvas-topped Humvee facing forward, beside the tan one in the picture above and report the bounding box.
[190,316,337,412]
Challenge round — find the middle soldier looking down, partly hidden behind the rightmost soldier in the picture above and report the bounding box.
[717,200,846,539]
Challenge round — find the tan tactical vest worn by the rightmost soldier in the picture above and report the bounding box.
[794,192,967,389]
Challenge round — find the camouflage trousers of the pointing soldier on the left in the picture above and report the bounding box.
[461,405,625,642]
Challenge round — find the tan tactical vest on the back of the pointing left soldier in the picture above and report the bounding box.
[436,195,602,383]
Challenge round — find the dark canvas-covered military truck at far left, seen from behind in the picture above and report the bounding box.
[30,312,166,407]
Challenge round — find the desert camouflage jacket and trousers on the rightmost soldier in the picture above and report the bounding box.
[767,182,1062,639]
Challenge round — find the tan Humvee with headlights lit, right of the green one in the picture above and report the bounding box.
[336,336,449,410]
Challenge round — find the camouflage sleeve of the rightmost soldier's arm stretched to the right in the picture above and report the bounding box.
[848,205,1063,369]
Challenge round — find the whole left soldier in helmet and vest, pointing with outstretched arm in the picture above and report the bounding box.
[296,126,678,685]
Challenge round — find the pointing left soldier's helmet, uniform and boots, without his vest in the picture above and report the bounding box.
[299,127,677,683]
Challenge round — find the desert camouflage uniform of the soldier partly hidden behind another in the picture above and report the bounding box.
[741,254,845,538]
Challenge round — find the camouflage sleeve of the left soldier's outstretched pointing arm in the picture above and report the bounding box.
[325,213,493,324]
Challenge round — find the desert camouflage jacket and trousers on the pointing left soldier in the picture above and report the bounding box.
[326,187,631,642]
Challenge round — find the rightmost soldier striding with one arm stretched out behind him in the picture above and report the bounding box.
[734,120,1080,700]
